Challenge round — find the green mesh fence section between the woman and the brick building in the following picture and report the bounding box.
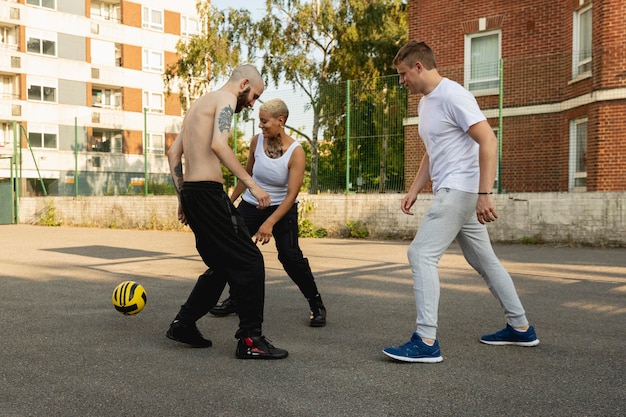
[251,75,407,194]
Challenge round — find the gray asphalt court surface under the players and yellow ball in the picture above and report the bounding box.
[0,225,626,417]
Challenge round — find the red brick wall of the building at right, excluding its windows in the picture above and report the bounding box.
[405,0,626,192]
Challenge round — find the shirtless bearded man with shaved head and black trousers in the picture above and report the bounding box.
[166,65,288,359]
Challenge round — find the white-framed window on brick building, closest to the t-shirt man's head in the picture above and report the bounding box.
[465,31,500,95]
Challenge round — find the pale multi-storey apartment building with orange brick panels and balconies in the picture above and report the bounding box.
[0,0,199,195]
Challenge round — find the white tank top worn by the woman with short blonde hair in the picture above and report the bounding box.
[241,133,301,206]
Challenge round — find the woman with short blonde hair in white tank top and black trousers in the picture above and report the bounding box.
[210,99,326,327]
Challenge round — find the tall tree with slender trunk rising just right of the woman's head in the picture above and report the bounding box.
[246,0,408,193]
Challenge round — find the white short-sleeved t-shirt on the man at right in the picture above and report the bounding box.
[417,78,486,193]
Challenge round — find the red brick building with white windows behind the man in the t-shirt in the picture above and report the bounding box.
[405,0,626,192]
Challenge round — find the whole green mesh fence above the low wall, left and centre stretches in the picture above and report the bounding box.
[7,76,407,196]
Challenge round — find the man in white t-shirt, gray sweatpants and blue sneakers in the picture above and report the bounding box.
[383,40,539,362]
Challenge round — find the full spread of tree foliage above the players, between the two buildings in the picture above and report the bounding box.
[165,0,408,193]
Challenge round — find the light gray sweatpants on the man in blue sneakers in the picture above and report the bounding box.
[407,188,528,339]
